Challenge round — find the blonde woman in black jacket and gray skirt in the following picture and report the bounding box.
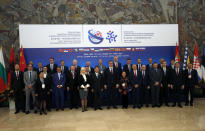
[79,67,90,112]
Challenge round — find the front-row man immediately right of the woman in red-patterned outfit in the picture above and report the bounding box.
[129,64,142,108]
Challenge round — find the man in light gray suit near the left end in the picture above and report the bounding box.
[24,64,37,114]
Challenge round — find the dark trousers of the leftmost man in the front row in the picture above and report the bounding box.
[14,91,25,111]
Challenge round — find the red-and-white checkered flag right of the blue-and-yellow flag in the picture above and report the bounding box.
[193,43,201,80]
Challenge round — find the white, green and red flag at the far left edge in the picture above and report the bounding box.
[0,47,8,92]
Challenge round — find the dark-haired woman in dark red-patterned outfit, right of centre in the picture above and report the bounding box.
[120,71,129,109]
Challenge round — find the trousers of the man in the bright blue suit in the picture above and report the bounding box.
[55,88,64,109]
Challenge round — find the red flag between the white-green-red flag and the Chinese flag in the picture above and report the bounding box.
[8,45,15,88]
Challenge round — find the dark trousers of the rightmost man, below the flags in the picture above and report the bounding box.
[185,86,194,104]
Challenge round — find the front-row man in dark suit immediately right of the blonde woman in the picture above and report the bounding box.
[91,66,103,110]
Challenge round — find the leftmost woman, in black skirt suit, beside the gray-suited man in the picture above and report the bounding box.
[35,72,49,115]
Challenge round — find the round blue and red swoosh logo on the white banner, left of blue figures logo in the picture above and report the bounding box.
[88,29,104,44]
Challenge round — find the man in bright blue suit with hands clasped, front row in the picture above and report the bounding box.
[53,67,66,111]
